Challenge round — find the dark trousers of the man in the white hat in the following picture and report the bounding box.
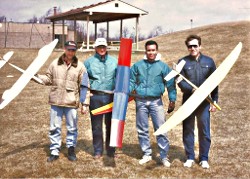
[89,94,115,155]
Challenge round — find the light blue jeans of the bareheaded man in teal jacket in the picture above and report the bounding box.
[136,98,169,159]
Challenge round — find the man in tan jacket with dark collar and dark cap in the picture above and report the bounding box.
[37,41,88,162]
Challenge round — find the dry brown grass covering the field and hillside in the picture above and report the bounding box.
[0,21,250,178]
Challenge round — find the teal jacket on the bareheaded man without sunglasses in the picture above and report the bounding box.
[129,56,176,101]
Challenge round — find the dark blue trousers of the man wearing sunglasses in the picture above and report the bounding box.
[183,101,211,161]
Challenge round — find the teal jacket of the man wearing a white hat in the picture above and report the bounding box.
[84,53,117,90]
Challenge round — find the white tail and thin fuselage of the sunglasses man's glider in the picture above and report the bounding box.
[164,60,221,110]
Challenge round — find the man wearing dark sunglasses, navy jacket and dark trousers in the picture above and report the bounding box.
[178,35,218,169]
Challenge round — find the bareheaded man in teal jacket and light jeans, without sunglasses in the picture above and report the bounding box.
[130,40,176,167]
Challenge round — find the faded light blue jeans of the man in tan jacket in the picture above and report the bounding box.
[49,105,78,155]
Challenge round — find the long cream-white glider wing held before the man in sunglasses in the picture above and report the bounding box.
[154,42,242,135]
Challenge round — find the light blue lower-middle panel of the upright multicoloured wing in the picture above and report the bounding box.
[112,92,128,120]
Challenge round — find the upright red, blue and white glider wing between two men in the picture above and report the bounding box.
[109,38,132,148]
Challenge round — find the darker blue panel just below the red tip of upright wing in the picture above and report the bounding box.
[115,65,130,94]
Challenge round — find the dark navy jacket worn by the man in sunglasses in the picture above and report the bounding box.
[178,54,218,103]
